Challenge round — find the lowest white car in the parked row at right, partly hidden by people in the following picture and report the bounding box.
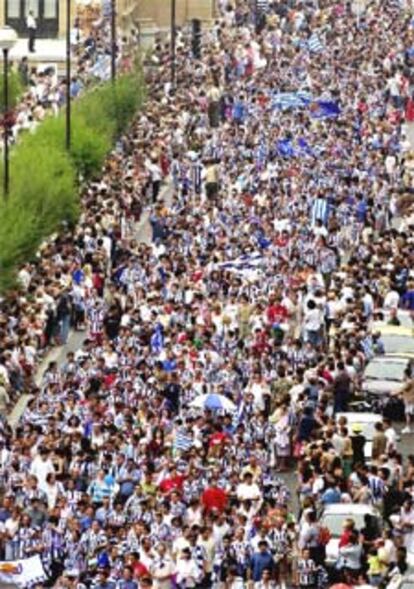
[319,503,382,567]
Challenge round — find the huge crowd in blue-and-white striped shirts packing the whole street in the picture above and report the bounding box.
[0,0,414,589]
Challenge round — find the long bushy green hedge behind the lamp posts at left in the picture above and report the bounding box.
[0,69,145,293]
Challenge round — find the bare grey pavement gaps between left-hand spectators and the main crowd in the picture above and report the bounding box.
[8,184,172,427]
